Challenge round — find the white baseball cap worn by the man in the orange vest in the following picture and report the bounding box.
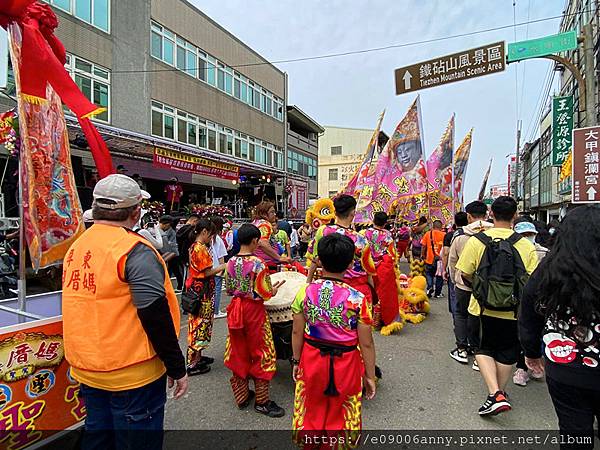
[94,173,150,209]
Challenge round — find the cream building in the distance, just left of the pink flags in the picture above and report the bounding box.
[318,126,373,197]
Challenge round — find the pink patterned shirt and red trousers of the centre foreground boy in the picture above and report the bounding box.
[292,279,372,441]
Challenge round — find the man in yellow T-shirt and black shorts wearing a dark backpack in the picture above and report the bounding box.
[456,196,538,416]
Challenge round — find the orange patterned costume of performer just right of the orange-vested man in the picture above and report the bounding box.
[185,242,215,362]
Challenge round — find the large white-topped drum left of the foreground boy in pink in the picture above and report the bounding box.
[265,272,306,359]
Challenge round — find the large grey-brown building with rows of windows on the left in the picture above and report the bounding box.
[2,0,292,217]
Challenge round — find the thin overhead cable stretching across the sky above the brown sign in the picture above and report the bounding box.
[111,10,592,75]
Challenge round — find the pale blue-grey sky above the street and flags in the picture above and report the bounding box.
[191,0,565,202]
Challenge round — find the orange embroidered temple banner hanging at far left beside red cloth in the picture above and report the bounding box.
[10,25,85,270]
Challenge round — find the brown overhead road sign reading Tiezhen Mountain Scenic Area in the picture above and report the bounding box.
[395,41,506,95]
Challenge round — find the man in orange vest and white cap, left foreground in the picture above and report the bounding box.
[62,174,188,449]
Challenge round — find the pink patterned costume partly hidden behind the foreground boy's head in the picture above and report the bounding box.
[308,225,376,307]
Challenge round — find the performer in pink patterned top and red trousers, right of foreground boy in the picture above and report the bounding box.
[362,212,399,325]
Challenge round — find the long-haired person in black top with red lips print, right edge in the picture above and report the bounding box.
[518,205,600,448]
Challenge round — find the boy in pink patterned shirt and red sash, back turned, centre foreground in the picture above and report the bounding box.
[292,233,376,442]
